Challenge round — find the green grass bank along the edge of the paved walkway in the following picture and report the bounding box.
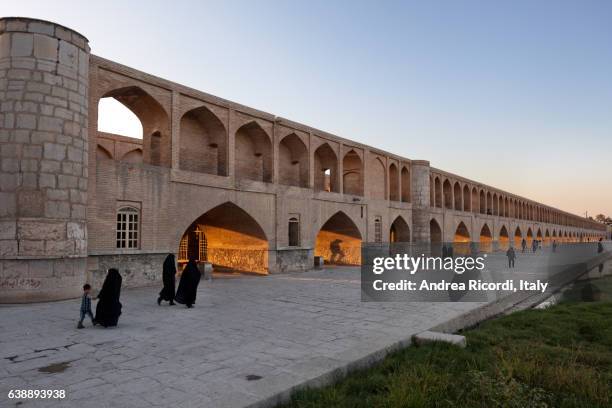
[284,302,612,408]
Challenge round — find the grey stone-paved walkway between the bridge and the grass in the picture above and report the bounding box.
[0,268,479,407]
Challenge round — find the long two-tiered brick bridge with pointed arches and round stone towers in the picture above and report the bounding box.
[0,18,605,302]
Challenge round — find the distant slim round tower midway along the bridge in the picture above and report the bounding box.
[410,160,431,243]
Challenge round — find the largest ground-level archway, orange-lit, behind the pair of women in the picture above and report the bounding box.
[178,202,268,274]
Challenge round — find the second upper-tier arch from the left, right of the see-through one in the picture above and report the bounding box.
[179,106,227,176]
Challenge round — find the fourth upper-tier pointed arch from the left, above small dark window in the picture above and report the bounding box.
[278,133,309,188]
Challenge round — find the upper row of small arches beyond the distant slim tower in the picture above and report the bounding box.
[430,175,593,228]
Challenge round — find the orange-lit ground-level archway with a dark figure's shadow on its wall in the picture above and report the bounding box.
[315,211,361,265]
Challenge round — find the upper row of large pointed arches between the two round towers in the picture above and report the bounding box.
[98,86,410,202]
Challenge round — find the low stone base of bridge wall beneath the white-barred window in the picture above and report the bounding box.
[87,253,168,293]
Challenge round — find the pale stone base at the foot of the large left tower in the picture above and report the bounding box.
[0,258,87,303]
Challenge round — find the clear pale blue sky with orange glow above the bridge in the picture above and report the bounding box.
[5,0,612,216]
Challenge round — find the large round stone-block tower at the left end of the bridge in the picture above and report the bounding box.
[0,17,89,303]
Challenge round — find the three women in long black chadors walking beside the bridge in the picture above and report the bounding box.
[94,254,200,327]
